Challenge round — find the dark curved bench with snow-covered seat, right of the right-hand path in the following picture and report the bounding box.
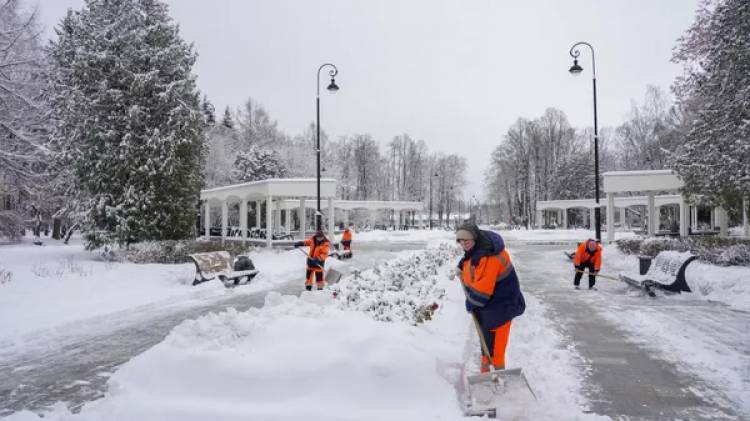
[620,251,697,297]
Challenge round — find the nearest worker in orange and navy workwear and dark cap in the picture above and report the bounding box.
[456,223,526,373]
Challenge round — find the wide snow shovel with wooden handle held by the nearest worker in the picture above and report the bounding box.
[461,285,536,418]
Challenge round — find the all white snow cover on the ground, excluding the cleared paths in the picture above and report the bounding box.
[0,230,750,421]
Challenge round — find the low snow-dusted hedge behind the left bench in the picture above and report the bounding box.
[127,240,250,263]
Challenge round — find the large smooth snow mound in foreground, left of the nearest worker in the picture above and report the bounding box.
[9,291,470,421]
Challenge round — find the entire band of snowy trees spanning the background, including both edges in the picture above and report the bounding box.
[0,0,750,244]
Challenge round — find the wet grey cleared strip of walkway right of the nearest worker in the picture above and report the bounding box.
[508,243,750,420]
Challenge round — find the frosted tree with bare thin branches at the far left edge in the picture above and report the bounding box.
[0,0,49,230]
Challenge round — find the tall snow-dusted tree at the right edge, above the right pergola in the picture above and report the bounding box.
[672,0,750,204]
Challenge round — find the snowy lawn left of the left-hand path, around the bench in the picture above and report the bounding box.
[0,238,347,345]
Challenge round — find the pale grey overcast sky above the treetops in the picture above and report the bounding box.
[32,0,698,194]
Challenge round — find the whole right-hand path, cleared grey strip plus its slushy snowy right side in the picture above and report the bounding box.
[508,242,750,420]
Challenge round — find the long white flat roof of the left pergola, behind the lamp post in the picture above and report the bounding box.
[200,178,336,202]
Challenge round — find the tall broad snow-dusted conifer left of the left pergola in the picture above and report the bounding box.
[50,0,205,247]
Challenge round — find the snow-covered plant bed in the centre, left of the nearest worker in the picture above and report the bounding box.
[332,243,459,324]
